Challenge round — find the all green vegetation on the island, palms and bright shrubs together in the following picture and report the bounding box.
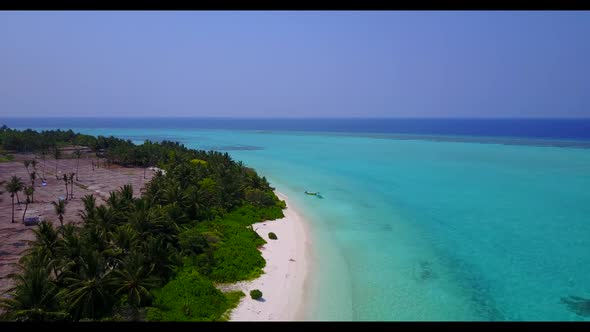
[0,127,285,321]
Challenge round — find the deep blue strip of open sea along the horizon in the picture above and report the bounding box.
[0,117,590,141]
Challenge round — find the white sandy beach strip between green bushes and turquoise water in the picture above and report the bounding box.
[230,192,310,321]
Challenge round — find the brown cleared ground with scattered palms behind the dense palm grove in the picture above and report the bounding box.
[0,154,153,294]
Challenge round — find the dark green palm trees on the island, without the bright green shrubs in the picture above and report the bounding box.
[0,126,284,320]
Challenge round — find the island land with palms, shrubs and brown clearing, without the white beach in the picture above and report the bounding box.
[0,126,286,321]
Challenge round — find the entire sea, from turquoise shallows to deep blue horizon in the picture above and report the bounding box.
[0,118,590,321]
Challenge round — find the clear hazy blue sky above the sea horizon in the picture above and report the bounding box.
[0,11,590,117]
